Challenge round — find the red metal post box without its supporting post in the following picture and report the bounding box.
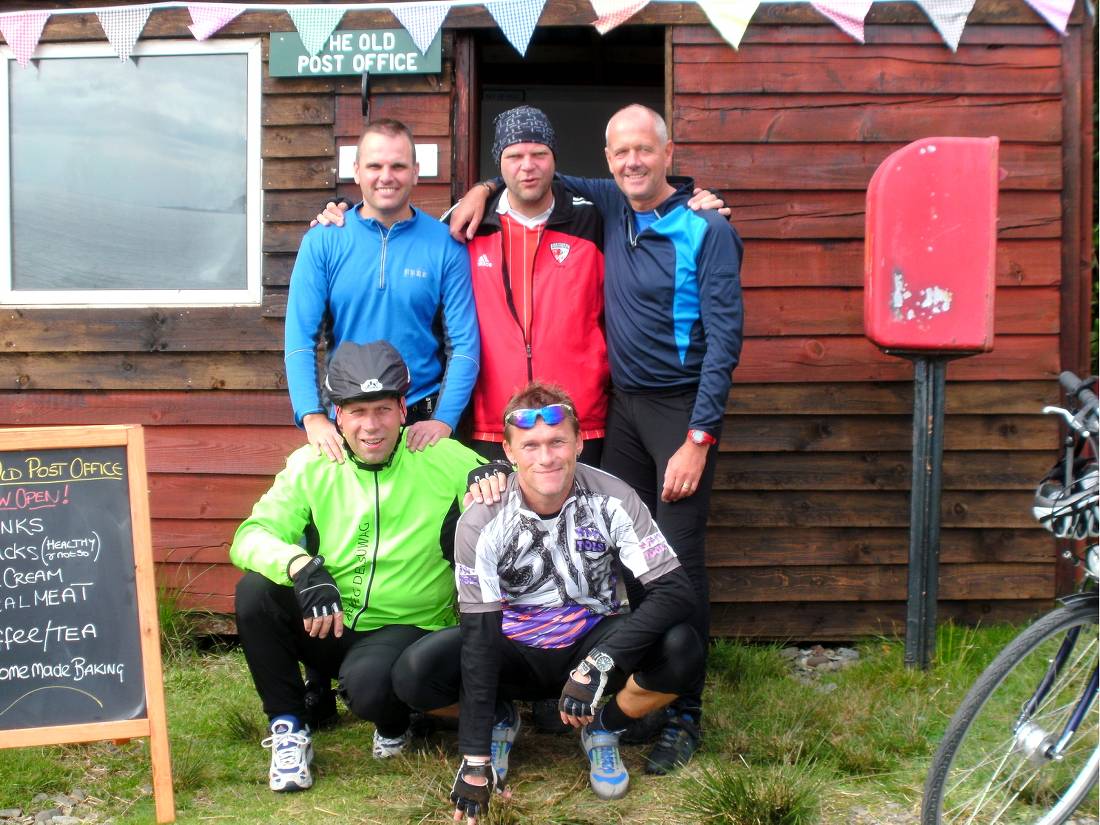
[864,138,999,353]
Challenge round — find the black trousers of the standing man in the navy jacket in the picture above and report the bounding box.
[601,388,721,710]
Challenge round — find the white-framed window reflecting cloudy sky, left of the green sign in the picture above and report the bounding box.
[0,39,263,306]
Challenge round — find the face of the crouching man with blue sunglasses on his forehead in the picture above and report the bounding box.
[504,418,584,516]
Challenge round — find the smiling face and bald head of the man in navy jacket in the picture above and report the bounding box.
[604,107,674,212]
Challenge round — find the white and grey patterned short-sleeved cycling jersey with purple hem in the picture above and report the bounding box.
[454,464,680,648]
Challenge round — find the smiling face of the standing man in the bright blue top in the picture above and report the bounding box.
[354,132,417,226]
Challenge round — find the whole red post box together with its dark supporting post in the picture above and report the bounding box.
[864,138,999,668]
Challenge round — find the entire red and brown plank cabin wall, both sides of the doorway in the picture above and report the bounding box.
[0,0,1091,639]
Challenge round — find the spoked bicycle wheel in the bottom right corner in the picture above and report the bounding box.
[921,598,1100,825]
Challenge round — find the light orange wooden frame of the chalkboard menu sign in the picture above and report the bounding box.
[0,425,176,823]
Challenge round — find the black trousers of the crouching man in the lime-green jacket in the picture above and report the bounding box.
[237,572,429,738]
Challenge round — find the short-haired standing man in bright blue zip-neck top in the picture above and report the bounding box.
[286,120,481,462]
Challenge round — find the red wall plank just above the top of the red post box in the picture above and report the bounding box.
[672,94,1062,144]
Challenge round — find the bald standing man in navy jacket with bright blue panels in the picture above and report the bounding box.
[451,106,743,773]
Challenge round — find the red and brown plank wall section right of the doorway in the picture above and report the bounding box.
[668,19,1088,638]
